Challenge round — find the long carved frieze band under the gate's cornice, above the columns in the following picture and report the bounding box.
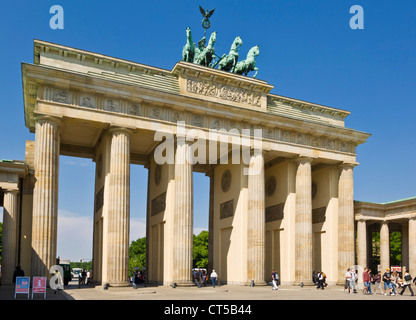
[30,81,356,154]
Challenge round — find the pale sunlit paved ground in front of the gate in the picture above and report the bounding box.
[0,282,416,301]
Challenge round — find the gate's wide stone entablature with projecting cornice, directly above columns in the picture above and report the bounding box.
[23,64,368,160]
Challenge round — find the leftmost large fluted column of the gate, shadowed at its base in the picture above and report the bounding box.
[31,117,60,277]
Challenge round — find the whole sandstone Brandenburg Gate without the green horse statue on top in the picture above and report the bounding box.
[6,35,369,286]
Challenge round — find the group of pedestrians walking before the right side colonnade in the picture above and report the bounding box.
[363,267,416,296]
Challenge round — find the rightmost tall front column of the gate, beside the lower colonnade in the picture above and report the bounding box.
[338,164,355,285]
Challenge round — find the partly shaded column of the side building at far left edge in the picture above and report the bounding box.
[1,189,19,285]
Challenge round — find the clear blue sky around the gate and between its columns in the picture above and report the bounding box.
[0,0,416,260]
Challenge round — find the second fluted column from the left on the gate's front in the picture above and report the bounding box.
[107,128,130,286]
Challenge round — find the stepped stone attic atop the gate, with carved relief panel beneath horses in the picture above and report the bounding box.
[34,40,360,131]
